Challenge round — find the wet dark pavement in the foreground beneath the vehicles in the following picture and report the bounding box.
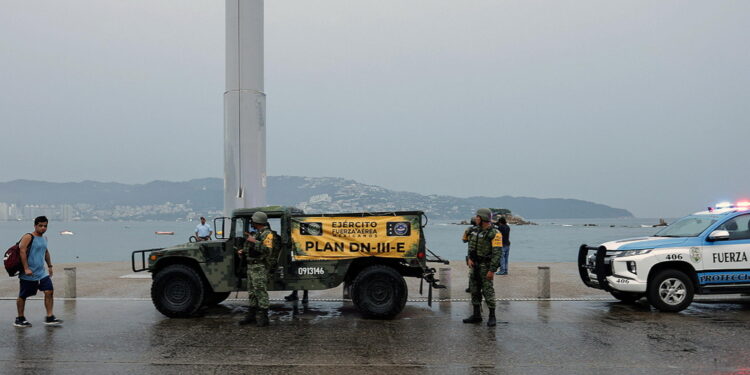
[0,300,750,374]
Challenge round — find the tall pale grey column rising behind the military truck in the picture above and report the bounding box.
[224,0,266,216]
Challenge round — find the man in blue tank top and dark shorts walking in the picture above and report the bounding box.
[13,216,62,328]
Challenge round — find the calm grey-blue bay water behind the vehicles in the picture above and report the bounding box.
[0,218,672,263]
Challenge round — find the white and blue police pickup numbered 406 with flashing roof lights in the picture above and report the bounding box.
[578,202,750,312]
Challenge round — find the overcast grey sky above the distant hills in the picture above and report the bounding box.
[0,0,750,217]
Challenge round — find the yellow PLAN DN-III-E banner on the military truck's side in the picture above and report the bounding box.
[292,215,421,260]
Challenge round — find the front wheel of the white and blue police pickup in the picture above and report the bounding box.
[647,270,695,312]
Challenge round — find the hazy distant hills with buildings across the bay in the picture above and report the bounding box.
[0,176,633,219]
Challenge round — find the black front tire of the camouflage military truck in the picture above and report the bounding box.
[151,264,206,318]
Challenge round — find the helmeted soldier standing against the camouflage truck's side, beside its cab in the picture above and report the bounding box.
[240,212,274,327]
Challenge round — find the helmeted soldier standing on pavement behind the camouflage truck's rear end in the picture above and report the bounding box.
[464,208,503,327]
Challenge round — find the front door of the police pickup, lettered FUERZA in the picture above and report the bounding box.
[699,214,750,286]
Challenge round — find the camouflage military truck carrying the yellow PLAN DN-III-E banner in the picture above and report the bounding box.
[131,206,447,319]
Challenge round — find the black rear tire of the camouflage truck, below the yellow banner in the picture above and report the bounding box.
[352,265,408,319]
